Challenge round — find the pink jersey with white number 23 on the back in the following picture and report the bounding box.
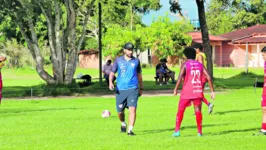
[180,60,203,99]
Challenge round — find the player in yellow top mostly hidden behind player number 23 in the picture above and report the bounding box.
[192,43,214,114]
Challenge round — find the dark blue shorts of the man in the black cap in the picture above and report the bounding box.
[116,89,139,112]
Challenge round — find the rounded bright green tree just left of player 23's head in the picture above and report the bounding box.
[147,16,193,58]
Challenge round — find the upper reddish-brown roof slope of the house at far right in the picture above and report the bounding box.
[220,24,266,40]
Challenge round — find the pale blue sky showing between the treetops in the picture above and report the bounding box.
[142,0,210,25]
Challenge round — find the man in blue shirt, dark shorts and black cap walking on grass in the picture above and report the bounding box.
[109,43,143,135]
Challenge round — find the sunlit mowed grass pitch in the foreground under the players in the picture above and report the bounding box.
[0,88,266,150]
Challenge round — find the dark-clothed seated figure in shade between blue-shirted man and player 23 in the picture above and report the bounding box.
[156,59,175,85]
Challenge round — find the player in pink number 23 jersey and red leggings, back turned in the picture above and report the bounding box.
[173,47,215,137]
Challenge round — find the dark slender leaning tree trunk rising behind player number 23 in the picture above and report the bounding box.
[196,0,213,79]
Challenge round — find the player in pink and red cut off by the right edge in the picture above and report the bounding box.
[260,46,266,135]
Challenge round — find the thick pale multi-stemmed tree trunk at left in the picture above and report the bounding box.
[15,0,95,84]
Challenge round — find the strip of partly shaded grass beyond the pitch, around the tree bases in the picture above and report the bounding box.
[2,67,263,98]
